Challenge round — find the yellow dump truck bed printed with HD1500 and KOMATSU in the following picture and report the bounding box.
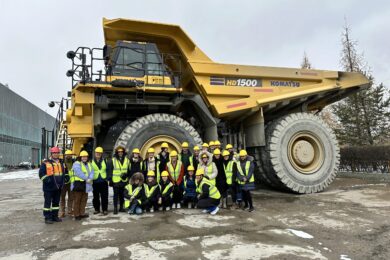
[103,19,368,120]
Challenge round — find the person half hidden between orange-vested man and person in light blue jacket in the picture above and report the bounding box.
[59,150,74,218]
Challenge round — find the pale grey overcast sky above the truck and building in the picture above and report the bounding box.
[0,0,390,115]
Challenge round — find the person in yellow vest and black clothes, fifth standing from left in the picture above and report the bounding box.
[108,146,130,215]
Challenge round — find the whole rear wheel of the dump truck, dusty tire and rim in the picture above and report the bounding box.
[260,113,340,194]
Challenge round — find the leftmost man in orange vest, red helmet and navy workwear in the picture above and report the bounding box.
[39,147,67,224]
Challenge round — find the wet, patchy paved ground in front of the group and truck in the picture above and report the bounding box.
[0,171,390,260]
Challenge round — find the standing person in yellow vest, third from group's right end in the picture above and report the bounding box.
[222,150,237,206]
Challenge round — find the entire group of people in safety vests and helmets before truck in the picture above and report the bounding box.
[39,141,255,224]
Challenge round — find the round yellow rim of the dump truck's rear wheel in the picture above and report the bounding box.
[288,132,325,174]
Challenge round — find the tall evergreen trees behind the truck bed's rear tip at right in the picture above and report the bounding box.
[332,23,390,145]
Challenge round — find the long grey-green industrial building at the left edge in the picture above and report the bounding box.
[0,83,55,169]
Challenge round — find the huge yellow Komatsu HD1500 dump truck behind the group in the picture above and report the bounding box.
[63,19,368,193]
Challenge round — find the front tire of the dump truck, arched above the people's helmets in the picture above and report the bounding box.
[115,113,202,151]
